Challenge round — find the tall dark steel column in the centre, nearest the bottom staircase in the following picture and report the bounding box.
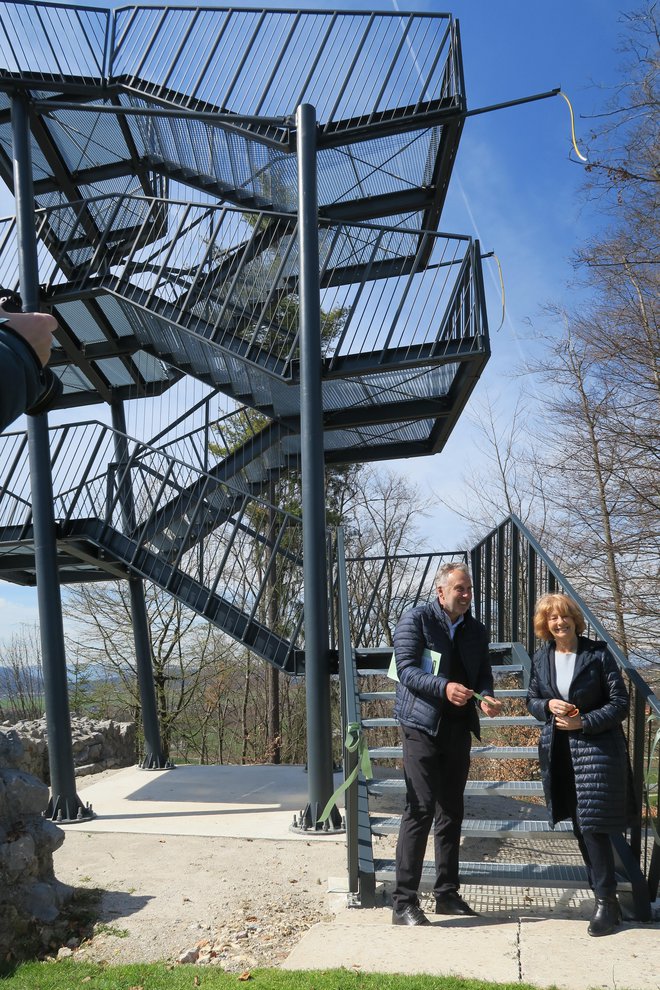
[296,104,341,829]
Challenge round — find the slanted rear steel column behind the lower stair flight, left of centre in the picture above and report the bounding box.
[111,400,174,770]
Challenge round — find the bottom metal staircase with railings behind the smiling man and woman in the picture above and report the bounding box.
[337,517,660,920]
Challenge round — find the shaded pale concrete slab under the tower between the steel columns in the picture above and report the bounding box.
[62,766,342,842]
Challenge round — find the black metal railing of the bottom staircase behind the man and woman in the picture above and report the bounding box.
[336,516,660,904]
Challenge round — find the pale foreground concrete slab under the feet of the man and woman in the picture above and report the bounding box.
[282,908,660,990]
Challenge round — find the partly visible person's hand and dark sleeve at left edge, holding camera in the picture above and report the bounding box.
[0,289,61,432]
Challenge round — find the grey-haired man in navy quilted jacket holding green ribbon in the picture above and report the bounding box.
[392,561,501,925]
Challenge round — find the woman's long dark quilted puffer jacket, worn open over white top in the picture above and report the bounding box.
[527,636,634,832]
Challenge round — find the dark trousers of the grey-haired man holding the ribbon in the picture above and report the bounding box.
[392,713,471,911]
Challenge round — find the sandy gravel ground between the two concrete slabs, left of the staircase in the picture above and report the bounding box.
[55,829,345,972]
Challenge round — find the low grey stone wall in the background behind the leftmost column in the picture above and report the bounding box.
[0,718,137,784]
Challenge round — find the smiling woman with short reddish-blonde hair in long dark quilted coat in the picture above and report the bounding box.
[527,594,634,935]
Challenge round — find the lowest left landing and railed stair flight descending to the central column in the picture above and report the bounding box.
[0,422,304,674]
